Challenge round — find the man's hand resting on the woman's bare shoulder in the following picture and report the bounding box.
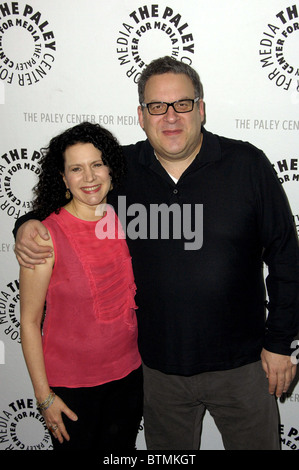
[15,220,53,269]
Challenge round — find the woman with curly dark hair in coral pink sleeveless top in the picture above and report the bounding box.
[20,123,142,450]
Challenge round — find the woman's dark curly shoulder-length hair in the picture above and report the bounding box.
[33,122,126,220]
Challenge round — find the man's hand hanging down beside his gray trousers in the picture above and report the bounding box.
[261,349,296,398]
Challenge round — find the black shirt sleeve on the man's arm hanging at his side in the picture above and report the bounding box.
[257,154,299,355]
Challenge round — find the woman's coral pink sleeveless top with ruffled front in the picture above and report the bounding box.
[43,206,141,387]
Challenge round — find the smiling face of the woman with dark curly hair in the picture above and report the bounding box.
[63,143,111,207]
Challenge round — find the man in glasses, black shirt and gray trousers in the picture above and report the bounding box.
[16,57,299,450]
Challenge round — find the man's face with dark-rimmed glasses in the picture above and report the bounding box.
[138,73,204,161]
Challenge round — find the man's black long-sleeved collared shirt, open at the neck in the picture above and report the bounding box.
[110,129,299,375]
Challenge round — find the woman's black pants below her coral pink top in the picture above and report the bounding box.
[52,367,143,451]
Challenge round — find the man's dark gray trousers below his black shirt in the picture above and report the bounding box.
[143,361,280,450]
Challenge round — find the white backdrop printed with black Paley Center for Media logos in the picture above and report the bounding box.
[0,0,299,450]
